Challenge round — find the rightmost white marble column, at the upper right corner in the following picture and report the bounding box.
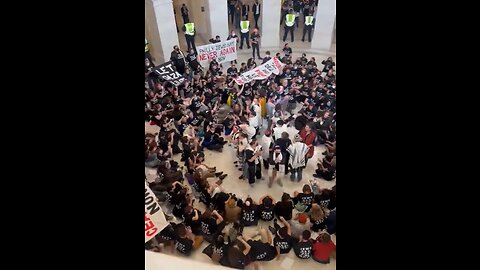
[312,0,336,51]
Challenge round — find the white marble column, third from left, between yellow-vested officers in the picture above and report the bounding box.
[254,0,281,48]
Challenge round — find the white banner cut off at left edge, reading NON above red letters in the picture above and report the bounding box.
[145,182,168,243]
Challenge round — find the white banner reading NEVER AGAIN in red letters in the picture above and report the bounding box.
[197,39,237,65]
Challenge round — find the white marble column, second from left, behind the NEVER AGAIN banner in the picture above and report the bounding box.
[205,0,228,41]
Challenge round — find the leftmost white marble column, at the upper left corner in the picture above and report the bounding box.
[145,0,181,65]
